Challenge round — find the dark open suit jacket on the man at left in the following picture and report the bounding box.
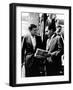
[22,36,42,64]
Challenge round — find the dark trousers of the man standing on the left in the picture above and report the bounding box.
[25,60,40,77]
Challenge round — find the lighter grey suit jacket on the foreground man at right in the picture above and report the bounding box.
[48,35,64,66]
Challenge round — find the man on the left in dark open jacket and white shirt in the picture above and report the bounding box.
[22,24,42,77]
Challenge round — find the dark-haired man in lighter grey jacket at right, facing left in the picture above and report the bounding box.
[45,25,64,75]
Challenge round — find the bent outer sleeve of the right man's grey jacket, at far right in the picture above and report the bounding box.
[51,36,64,56]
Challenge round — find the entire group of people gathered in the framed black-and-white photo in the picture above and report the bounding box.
[22,15,64,77]
